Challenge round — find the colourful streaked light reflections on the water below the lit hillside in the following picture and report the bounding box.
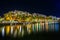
[0,23,59,37]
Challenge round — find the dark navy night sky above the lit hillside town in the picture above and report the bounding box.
[0,0,60,17]
